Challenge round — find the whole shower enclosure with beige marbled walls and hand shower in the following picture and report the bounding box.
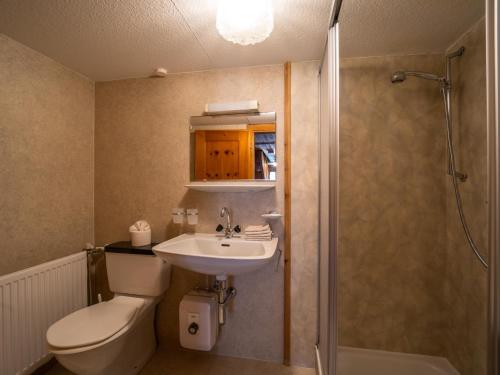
[317,0,500,375]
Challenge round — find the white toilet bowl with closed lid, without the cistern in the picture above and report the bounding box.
[47,296,156,375]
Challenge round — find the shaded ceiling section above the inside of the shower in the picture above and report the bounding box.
[339,0,485,57]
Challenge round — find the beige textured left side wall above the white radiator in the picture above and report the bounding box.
[0,34,94,275]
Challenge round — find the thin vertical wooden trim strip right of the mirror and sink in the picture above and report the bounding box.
[283,62,292,365]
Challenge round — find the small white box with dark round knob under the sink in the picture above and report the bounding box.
[179,294,219,351]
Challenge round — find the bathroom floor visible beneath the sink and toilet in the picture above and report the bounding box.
[44,348,315,375]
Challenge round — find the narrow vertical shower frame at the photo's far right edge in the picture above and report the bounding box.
[485,0,500,375]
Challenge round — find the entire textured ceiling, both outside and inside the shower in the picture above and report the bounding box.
[0,0,484,81]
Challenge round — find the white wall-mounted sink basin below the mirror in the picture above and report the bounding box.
[153,233,278,276]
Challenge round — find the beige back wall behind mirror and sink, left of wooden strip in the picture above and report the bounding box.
[95,65,284,361]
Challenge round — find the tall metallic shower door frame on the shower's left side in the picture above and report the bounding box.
[316,0,342,375]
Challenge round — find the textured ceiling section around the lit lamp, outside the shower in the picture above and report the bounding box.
[0,0,331,81]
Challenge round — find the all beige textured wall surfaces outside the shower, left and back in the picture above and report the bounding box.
[0,36,318,366]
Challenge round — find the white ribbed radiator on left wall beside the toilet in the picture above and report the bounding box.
[0,251,87,375]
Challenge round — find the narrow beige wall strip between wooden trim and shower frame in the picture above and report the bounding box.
[291,61,319,367]
